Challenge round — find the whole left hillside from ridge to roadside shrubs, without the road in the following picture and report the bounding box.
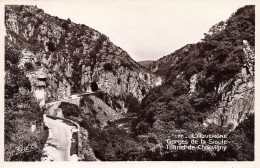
[5,5,161,161]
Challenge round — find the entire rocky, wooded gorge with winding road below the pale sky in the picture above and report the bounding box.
[5,5,255,161]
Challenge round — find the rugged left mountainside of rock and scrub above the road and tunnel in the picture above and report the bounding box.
[5,5,161,104]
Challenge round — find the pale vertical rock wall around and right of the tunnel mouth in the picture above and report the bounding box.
[81,67,161,101]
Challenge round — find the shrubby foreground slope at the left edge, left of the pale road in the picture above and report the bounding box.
[4,46,47,161]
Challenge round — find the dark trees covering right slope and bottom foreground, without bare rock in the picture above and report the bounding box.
[82,6,255,160]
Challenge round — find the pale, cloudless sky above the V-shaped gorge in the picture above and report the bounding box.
[23,0,252,61]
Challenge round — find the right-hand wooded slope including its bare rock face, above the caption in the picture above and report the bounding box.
[137,6,255,128]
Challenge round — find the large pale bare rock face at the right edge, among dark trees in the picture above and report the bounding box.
[204,40,255,128]
